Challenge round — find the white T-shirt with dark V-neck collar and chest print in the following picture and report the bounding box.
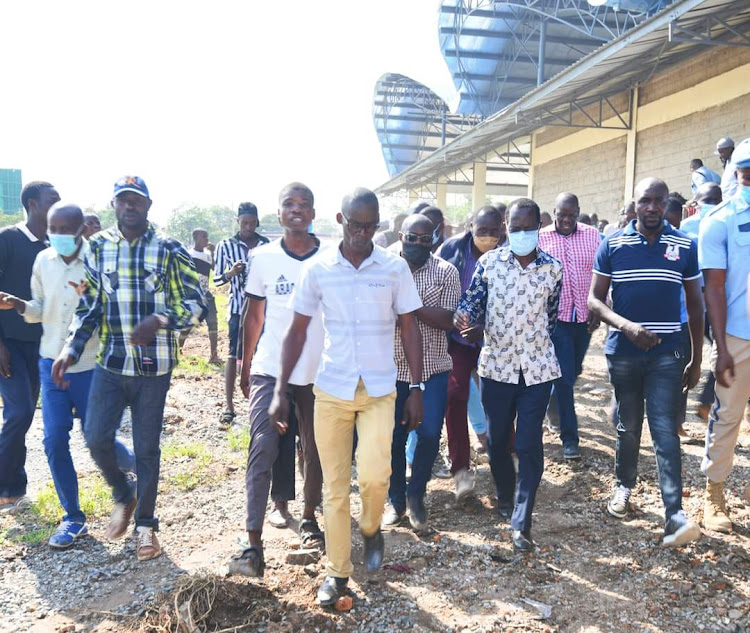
[245,238,323,385]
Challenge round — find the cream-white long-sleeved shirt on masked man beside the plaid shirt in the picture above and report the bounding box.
[23,241,99,374]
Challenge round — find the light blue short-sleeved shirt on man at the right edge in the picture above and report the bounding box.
[698,195,750,340]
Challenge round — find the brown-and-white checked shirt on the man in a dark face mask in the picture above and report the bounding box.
[388,242,461,382]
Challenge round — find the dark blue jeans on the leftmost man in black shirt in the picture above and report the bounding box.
[0,339,39,497]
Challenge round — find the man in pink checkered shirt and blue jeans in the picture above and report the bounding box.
[539,193,602,460]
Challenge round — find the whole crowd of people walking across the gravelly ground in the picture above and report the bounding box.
[0,133,750,605]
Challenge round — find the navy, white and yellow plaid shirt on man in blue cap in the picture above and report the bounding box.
[64,224,205,376]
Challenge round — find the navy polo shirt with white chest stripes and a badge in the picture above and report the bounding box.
[594,220,700,356]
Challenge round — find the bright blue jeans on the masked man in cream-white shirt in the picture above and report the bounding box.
[39,358,135,523]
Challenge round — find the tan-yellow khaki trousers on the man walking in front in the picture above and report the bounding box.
[314,379,396,578]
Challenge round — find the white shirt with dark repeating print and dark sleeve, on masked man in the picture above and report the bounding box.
[458,248,563,386]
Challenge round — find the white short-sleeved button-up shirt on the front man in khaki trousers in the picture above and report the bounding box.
[292,245,422,400]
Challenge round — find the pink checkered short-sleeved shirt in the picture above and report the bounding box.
[539,223,602,323]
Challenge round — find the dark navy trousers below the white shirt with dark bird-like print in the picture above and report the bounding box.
[482,375,552,534]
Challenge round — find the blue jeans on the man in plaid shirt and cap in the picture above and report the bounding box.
[84,365,172,529]
